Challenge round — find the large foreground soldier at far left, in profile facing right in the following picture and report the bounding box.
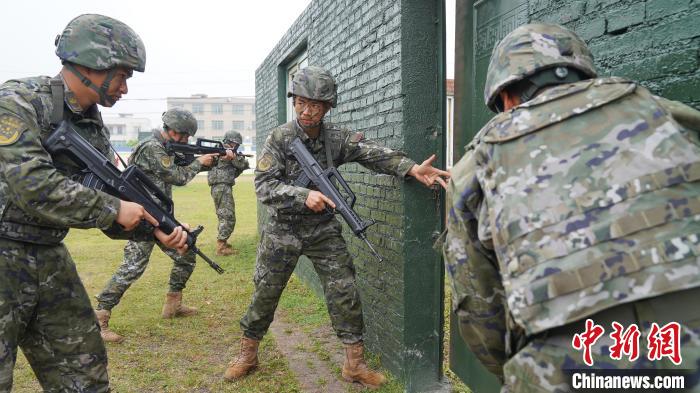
[0,15,186,392]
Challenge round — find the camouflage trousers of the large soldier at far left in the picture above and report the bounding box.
[0,239,109,392]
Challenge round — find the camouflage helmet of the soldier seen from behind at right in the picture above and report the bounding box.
[484,24,597,112]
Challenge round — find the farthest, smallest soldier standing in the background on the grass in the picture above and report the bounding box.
[207,131,250,256]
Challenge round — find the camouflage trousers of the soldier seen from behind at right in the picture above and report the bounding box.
[501,289,700,393]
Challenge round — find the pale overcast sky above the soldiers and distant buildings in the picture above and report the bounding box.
[0,0,455,126]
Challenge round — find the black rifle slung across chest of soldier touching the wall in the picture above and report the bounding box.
[290,138,384,262]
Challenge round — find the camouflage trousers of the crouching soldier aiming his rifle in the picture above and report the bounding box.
[96,240,196,310]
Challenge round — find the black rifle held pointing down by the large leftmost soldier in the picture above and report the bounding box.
[44,121,224,274]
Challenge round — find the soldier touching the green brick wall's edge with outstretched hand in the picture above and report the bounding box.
[224,66,449,388]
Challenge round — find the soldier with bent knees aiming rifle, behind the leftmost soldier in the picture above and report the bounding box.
[95,108,233,342]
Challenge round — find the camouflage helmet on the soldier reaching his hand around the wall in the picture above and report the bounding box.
[287,66,338,108]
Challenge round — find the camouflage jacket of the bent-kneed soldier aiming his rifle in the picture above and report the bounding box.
[129,131,203,198]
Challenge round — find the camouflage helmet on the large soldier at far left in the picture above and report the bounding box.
[55,14,146,72]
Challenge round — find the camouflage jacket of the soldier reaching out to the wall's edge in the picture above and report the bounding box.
[255,121,415,222]
